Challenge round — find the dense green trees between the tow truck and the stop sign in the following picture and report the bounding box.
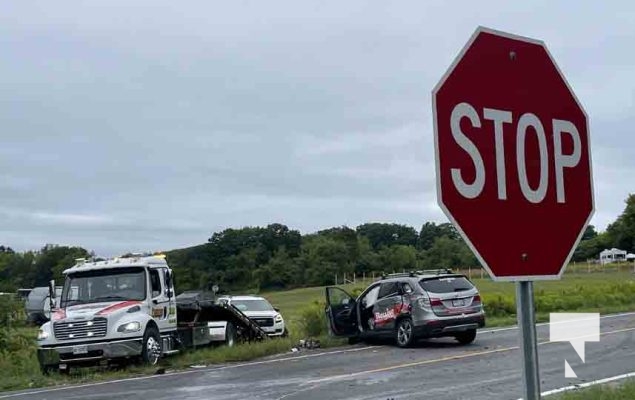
[167,222,478,290]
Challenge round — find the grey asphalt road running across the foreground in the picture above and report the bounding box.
[0,313,635,400]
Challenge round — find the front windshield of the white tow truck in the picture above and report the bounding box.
[60,267,146,308]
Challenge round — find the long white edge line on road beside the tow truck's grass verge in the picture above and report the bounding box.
[0,346,379,399]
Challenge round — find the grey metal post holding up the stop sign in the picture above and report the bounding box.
[516,281,540,400]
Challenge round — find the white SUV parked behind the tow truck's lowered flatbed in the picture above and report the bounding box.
[224,296,289,336]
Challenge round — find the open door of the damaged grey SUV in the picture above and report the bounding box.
[325,287,358,337]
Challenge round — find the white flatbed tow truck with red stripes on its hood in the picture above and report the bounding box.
[37,254,268,373]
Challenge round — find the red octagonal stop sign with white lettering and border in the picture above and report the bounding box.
[432,28,593,280]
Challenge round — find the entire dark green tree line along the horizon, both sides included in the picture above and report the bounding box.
[0,195,635,292]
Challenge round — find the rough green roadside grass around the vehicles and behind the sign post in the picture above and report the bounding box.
[0,269,635,392]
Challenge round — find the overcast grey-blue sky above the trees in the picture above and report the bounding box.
[0,0,635,255]
